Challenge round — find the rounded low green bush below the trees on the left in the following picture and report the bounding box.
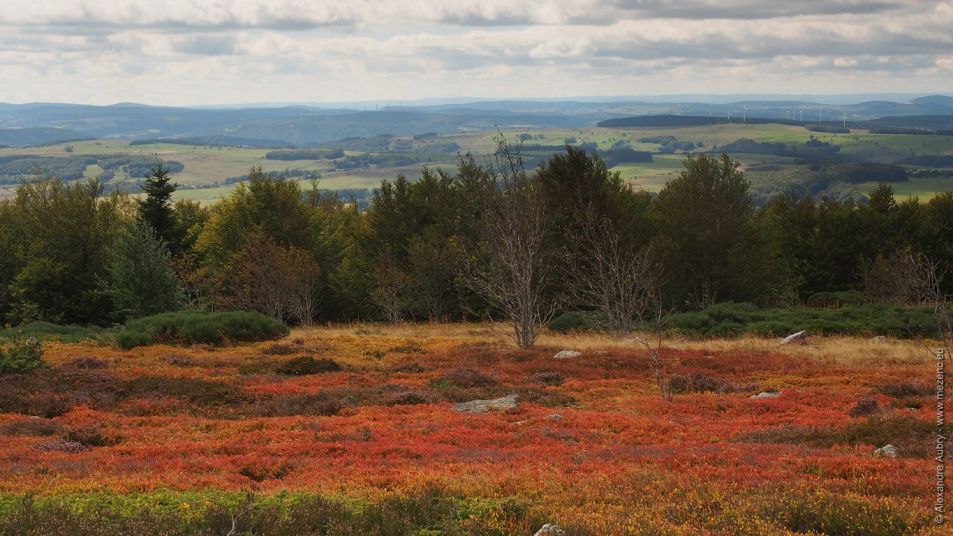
[116,311,288,350]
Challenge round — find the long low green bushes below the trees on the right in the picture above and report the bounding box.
[663,302,939,338]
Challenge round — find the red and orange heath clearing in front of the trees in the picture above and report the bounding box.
[0,324,949,535]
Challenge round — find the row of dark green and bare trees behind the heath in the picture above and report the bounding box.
[0,139,953,345]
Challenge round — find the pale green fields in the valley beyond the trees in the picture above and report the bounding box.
[0,124,953,203]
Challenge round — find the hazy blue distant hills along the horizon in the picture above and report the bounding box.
[0,95,953,148]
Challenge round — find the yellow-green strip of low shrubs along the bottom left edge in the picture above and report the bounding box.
[0,488,544,536]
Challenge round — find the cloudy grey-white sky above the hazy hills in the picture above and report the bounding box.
[0,0,953,105]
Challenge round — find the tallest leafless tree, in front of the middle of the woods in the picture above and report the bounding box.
[462,134,559,347]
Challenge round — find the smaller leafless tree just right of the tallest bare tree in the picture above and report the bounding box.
[566,207,661,333]
